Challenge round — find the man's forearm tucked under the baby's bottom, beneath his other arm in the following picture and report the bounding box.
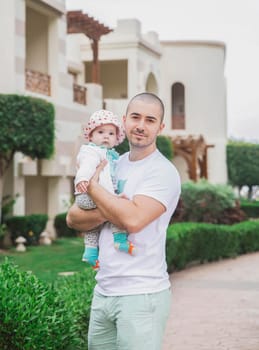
[66,204,107,231]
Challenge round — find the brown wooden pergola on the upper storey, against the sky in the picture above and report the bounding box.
[67,11,112,84]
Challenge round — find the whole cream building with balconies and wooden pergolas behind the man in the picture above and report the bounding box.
[0,0,227,235]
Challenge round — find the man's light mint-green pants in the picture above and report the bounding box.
[88,289,172,350]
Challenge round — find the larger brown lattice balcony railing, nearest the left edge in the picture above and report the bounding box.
[25,68,51,96]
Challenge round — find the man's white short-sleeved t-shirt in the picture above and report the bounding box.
[95,150,181,296]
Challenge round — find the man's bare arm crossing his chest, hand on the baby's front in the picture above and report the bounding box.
[88,176,166,233]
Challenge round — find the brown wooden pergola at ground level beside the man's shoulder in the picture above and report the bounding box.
[171,135,214,181]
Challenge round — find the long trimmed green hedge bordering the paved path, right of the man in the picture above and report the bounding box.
[166,221,259,272]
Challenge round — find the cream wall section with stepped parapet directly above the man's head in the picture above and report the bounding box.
[80,19,161,115]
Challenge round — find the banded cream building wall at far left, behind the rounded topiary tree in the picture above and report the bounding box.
[0,0,102,233]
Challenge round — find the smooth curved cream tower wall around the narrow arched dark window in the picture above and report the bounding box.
[161,42,227,183]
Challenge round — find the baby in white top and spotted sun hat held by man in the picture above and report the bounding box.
[75,109,135,270]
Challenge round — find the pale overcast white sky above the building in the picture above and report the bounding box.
[66,0,259,142]
